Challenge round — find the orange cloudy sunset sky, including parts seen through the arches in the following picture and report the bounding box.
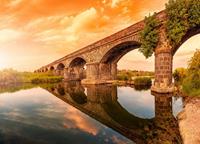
[0,0,200,71]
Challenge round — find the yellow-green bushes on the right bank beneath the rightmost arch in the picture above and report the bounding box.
[173,50,200,96]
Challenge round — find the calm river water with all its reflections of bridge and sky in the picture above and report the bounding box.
[0,82,183,144]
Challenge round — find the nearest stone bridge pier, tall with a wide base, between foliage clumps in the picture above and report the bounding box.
[151,25,174,93]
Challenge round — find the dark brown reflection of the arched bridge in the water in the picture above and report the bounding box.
[45,82,182,144]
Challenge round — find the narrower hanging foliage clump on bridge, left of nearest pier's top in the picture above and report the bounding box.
[139,14,159,58]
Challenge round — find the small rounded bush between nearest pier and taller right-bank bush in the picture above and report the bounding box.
[173,68,187,84]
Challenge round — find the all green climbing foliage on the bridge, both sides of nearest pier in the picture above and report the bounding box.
[139,0,200,58]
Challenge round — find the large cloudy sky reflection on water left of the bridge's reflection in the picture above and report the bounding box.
[0,88,131,144]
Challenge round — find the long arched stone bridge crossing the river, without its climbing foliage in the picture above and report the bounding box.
[35,11,200,93]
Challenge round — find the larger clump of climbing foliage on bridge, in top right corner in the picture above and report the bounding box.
[166,0,200,47]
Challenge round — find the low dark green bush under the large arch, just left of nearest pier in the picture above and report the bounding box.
[134,77,152,86]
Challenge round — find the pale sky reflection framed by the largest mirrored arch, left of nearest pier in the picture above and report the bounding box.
[117,87,155,118]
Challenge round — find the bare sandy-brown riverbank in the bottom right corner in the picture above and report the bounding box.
[178,97,200,144]
